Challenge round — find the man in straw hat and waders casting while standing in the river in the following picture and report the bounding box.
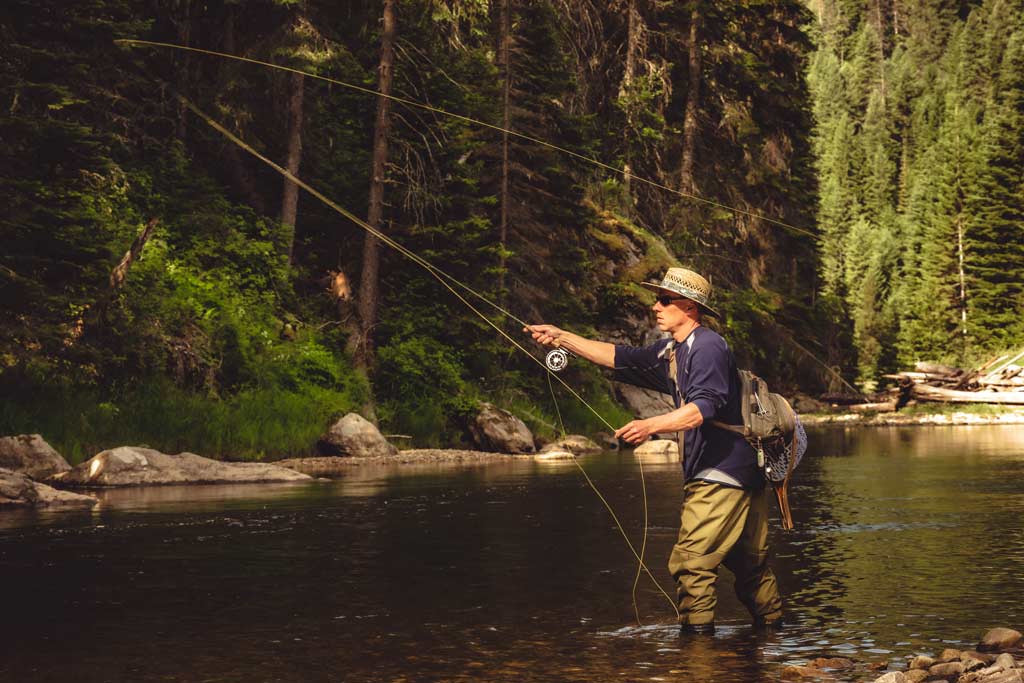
[526,268,782,634]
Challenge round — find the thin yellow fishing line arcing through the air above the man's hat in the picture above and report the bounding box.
[114,38,817,238]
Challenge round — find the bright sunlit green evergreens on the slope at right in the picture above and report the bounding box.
[808,0,1024,383]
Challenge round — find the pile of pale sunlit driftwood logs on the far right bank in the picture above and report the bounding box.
[857,351,1024,412]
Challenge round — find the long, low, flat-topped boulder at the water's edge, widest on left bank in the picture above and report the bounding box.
[51,446,310,486]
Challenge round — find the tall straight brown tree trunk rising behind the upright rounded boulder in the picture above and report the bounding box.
[354,0,395,368]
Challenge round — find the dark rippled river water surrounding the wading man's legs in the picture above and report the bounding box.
[0,426,1024,682]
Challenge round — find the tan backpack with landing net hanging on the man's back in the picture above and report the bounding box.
[669,350,807,530]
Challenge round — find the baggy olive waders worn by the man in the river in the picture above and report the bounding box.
[669,480,782,625]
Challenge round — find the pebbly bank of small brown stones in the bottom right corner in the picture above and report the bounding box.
[781,628,1024,683]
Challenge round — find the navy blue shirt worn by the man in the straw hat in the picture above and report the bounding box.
[615,327,764,489]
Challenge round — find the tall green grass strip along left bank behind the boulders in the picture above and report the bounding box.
[0,381,362,464]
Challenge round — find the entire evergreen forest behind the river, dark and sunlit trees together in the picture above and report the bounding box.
[0,0,1024,462]
